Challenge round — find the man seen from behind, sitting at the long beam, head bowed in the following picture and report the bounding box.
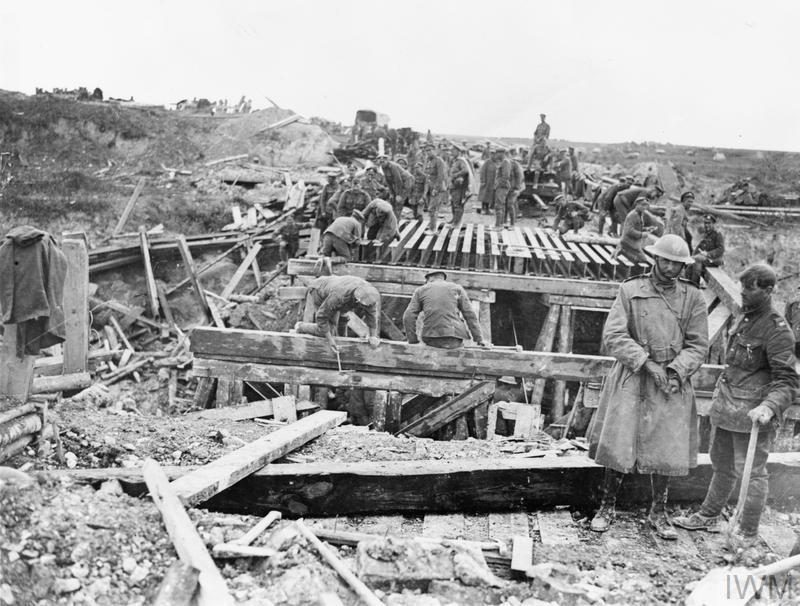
[403,269,489,349]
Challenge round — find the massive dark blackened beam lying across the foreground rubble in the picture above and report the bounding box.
[54,452,800,516]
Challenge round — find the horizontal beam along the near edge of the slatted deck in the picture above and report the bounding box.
[287,259,619,299]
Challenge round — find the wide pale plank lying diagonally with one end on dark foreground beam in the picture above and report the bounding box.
[171,410,347,505]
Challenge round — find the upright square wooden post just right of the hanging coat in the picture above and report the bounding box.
[61,238,89,374]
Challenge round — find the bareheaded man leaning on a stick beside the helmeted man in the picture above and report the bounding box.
[675,264,798,544]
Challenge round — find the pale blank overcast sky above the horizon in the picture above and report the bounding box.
[0,0,800,151]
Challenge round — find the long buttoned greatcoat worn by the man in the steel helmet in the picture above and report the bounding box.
[588,275,708,476]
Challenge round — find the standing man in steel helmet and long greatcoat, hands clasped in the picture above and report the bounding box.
[587,234,708,540]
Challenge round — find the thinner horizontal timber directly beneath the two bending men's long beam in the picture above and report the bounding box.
[192,358,469,400]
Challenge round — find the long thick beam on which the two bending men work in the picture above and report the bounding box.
[190,330,722,393]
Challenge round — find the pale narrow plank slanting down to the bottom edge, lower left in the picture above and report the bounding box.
[142,459,234,606]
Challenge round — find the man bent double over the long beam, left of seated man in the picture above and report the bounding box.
[294,276,381,352]
